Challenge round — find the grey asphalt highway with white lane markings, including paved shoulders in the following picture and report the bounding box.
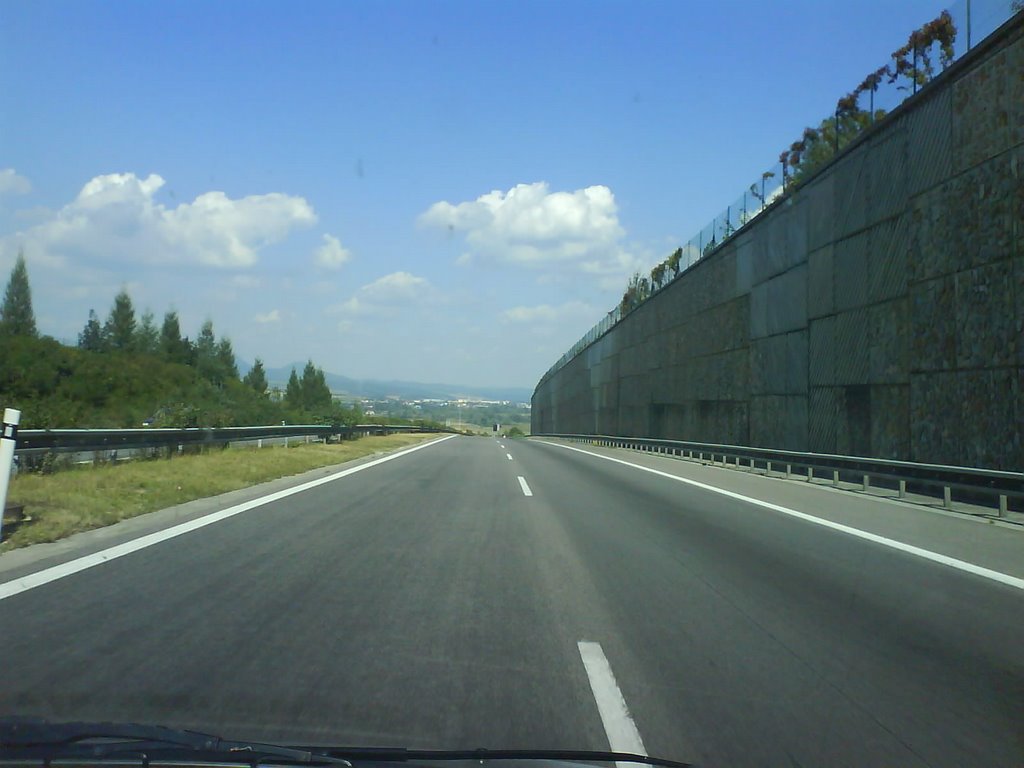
[0,437,1024,766]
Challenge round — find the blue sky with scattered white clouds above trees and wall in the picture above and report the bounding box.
[0,0,945,387]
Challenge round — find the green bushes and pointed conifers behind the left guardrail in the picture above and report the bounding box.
[0,253,360,428]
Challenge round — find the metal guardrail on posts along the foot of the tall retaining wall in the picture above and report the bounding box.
[530,434,1024,517]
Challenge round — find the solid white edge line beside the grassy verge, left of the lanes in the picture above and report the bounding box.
[0,435,456,600]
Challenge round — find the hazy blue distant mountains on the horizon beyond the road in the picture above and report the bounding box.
[239,360,534,402]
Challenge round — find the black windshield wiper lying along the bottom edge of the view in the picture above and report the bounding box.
[0,718,693,768]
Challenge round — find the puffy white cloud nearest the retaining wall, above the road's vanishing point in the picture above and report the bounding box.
[419,181,635,275]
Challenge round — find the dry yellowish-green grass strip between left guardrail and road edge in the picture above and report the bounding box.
[0,434,444,552]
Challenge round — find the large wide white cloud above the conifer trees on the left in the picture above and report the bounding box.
[3,173,316,267]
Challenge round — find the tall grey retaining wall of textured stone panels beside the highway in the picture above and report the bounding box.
[532,16,1024,470]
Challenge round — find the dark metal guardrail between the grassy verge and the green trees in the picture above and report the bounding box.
[14,424,452,456]
